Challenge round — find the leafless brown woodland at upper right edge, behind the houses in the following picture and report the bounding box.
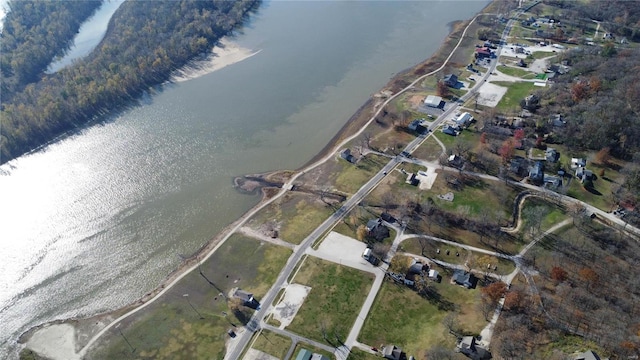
[541,47,640,158]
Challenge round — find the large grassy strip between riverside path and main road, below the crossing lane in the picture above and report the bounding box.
[89,235,291,359]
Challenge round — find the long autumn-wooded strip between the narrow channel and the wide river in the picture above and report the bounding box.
[0,0,259,162]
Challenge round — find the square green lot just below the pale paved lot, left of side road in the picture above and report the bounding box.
[287,257,373,346]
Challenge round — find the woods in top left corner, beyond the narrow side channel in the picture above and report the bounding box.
[0,0,102,99]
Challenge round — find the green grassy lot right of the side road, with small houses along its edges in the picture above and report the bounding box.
[358,273,486,359]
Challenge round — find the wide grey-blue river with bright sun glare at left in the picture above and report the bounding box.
[0,1,488,358]
